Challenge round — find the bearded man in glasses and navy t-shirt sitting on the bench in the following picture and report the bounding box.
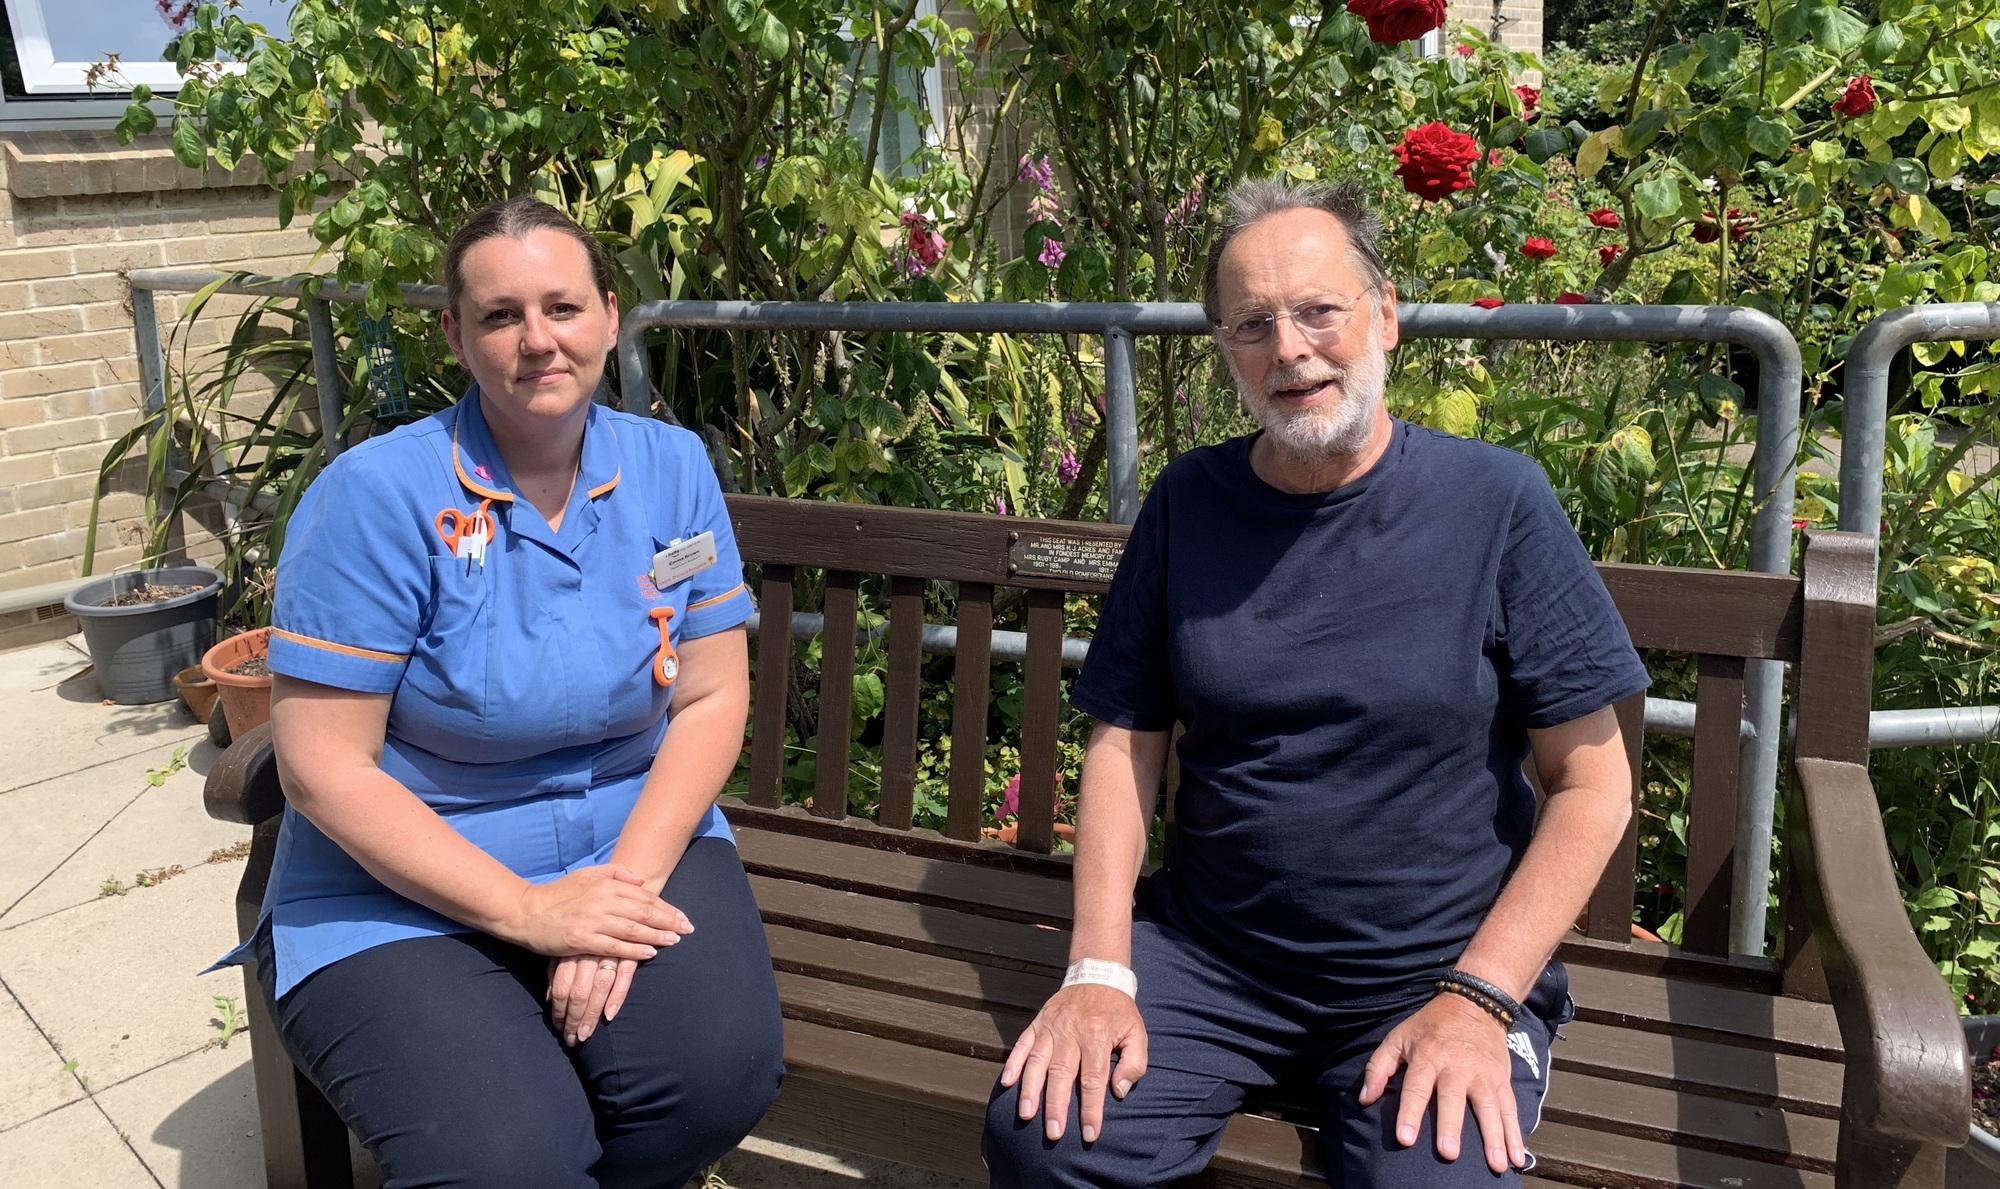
[986,180,1646,1189]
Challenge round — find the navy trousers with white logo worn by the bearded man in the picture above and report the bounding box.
[984,896,1574,1189]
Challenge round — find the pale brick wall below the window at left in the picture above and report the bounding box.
[0,132,314,647]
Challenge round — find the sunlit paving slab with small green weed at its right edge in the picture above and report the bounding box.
[0,863,242,1088]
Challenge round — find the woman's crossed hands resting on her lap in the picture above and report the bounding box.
[508,863,694,1045]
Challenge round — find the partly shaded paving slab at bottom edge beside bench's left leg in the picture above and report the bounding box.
[98,1037,264,1189]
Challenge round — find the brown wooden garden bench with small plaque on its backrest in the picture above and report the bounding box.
[208,496,1970,1189]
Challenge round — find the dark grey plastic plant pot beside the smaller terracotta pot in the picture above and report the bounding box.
[62,564,222,707]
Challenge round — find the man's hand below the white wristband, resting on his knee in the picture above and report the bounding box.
[1000,983,1146,1143]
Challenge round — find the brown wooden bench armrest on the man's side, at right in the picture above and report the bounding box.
[1790,759,1972,1147]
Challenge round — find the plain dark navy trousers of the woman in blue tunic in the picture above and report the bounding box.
[258,839,784,1189]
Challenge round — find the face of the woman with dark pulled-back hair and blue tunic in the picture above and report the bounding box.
[444,228,618,424]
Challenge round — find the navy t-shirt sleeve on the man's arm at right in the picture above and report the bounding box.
[1494,464,1650,729]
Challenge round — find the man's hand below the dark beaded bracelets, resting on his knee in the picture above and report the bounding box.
[1360,995,1528,1173]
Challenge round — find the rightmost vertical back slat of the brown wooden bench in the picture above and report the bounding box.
[1680,653,1744,955]
